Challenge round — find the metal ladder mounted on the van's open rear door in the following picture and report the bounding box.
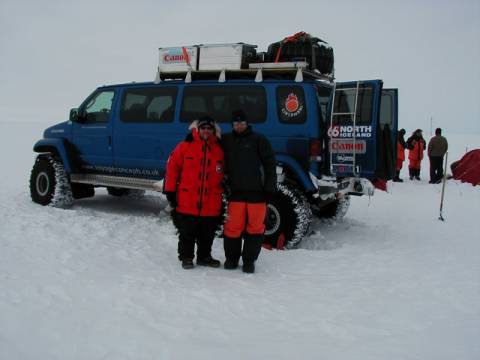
[328,81,360,176]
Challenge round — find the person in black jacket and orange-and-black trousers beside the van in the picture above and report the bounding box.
[222,110,277,273]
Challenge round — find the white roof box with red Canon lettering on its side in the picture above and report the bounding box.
[158,45,198,73]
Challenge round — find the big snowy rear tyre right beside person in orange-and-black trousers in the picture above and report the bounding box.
[264,184,312,249]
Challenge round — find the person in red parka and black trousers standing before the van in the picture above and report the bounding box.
[163,117,224,269]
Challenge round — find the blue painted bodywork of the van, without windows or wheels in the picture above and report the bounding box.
[35,79,394,192]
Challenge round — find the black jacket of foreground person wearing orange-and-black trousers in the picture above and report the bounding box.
[222,126,277,202]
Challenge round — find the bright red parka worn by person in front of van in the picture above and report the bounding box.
[164,128,224,216]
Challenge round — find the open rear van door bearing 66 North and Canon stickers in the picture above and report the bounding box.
[328,80,383,179]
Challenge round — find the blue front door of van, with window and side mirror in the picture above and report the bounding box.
[72,89,115,172]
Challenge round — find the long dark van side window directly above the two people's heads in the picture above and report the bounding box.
[180,85,267,123]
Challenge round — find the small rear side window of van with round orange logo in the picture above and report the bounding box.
[277,86,307,124]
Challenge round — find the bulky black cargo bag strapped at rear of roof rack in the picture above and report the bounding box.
[265,32,334,76]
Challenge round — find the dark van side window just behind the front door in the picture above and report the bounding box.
[120,87,177,123]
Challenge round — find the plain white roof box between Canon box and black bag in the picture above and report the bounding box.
[198,43,257,70]
